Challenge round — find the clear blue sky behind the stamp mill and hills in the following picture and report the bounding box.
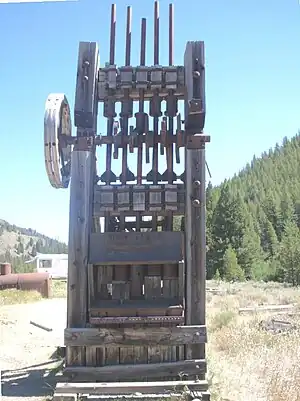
[0,0,300,241]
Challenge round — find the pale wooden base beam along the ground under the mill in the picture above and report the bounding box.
[53,380,210,401]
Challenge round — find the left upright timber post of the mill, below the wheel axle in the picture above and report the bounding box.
[66,150,95,366]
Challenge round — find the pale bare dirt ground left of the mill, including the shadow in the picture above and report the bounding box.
[0,299,67,401]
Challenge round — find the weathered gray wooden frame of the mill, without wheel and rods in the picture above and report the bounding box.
[57,12,207,395]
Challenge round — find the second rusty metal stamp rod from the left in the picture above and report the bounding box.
[120,6,134,185]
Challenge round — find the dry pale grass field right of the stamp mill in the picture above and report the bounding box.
[207,282,300,401]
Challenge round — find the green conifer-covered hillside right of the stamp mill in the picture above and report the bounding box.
[207,133,300,284]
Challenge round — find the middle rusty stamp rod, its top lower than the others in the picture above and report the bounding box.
[136,18,149,185]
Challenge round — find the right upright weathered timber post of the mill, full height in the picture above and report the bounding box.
[184,42,206,358]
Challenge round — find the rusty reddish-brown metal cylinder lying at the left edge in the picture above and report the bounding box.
[0,273,51,298]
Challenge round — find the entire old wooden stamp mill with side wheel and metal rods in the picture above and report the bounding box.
[44,2,210,400]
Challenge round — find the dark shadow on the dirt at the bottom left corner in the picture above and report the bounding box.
[2,359,62,397]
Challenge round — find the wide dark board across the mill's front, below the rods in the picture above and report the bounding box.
[89,231,182,265]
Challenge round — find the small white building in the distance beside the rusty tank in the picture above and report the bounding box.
[26,253,68,279]
